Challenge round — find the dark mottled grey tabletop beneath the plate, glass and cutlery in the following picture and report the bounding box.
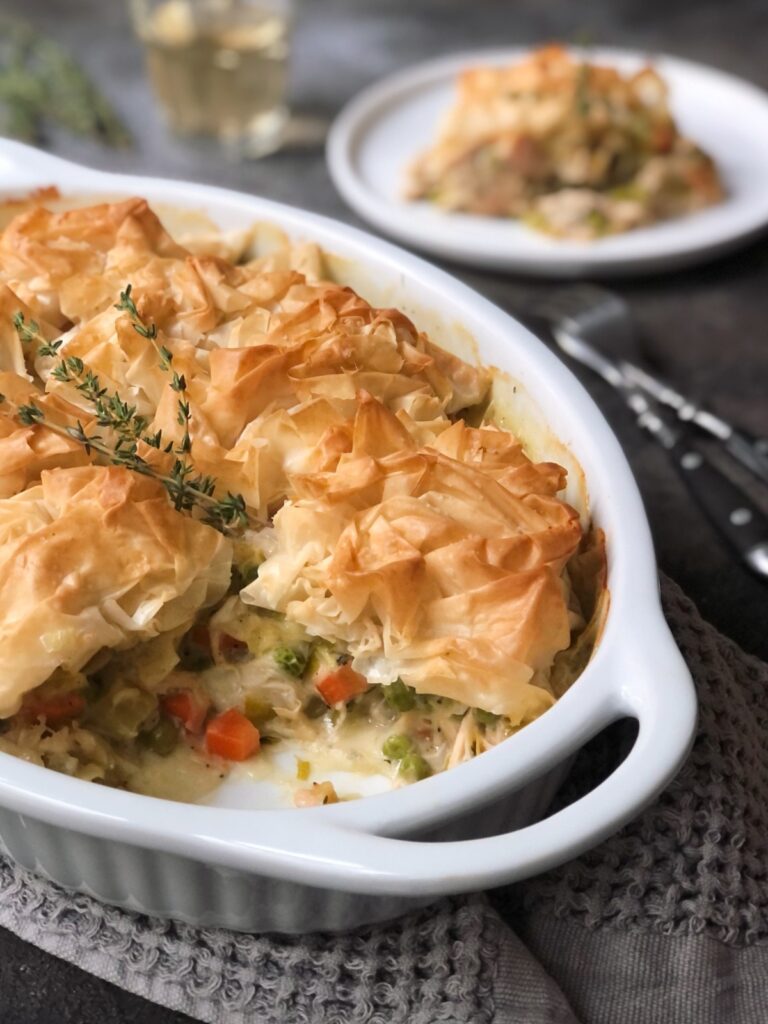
[0,0,768,1024]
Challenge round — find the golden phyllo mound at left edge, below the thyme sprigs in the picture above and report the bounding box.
[0,466,231,715]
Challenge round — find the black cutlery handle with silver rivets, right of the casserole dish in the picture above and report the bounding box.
[669,436,768,580]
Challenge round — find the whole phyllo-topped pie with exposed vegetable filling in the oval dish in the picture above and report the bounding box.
[0,192,603,804]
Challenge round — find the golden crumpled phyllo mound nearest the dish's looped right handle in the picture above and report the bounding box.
[249,394,581,725]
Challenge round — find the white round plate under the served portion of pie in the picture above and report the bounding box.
[327,49,768,278]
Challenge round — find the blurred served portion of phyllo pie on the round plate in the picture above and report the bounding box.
[406,46,723,240]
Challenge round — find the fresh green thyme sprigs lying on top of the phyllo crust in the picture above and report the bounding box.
[9,305,250,534]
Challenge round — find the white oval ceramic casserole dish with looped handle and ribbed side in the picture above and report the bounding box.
[0,141,695,932]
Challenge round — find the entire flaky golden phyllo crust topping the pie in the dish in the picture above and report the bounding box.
[0,193,582,724]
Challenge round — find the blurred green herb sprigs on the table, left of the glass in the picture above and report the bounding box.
[0,16,131,147]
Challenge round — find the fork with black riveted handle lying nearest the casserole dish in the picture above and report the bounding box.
[531,286,768,580]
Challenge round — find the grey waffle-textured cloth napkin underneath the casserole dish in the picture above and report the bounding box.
[0,581,768,1024]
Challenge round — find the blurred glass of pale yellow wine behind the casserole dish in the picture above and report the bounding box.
[131,0,292,157]
